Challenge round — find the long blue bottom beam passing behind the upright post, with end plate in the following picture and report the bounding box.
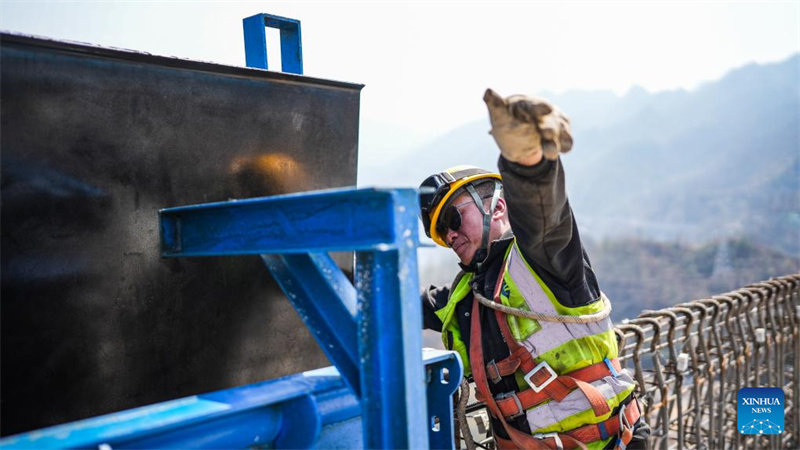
[0,350,462,450]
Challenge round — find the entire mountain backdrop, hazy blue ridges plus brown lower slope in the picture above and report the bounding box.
[359,54,800,320]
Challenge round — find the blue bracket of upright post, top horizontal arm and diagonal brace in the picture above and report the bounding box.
[160,189,452,448]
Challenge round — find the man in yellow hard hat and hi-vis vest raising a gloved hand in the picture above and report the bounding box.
[420,89,649,449]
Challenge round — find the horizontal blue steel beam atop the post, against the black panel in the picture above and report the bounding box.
[159,189,400,257]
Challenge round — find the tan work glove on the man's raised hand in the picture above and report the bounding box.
[483,89,572,163]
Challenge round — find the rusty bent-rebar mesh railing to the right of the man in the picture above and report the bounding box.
[616,274,800,449]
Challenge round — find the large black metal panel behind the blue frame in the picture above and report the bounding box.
[0,34,362,435]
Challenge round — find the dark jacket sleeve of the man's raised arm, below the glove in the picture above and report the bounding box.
[498,156,600,307]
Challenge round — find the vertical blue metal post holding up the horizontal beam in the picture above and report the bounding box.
[356,190,428,448]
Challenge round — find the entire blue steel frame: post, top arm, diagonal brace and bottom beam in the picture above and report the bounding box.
[0,189,463,449]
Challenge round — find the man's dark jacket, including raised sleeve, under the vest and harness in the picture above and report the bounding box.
[422,157,648,438]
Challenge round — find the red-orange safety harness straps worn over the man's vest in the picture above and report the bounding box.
[469,268,640,450]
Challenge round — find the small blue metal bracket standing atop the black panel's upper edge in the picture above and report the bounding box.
[242,13,303,75]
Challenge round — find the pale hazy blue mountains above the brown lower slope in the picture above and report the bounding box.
[359,55,800,257]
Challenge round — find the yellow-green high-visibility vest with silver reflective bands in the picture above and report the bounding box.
[436,239,635,449]
